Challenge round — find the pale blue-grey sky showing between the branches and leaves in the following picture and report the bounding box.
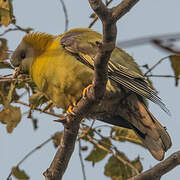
[0,0,180,180]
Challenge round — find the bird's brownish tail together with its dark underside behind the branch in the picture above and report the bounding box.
[89,93,171,161]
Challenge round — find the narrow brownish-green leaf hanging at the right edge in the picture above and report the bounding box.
[169,55,180,86]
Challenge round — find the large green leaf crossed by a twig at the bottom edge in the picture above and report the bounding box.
[104,152,143,180]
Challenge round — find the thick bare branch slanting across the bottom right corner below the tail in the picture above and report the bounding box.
[130,151,180,180]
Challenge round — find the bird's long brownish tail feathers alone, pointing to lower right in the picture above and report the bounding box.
[128,99,172,161]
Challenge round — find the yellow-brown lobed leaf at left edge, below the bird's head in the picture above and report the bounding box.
[0,105,21,133]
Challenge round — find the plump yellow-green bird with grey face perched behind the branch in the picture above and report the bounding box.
[11,28,172,161]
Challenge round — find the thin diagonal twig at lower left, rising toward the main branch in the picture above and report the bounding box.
[7,137,53,180]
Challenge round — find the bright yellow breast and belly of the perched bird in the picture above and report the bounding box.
[30,38,93,109]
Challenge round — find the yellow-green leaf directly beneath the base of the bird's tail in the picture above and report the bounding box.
[111,126,144,147]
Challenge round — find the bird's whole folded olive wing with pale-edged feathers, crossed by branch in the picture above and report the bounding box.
[60,29,169,113]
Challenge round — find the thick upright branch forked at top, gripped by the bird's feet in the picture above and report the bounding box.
[44,0,138,180]
